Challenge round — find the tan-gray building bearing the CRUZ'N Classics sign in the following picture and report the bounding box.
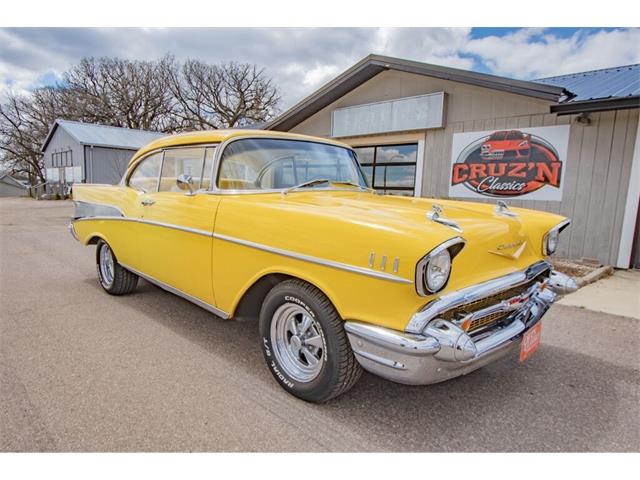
[265,55,640,268]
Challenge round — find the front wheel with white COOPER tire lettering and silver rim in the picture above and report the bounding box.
[260,280,362,402]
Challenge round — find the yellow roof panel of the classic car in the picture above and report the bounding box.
[129,129,351,165]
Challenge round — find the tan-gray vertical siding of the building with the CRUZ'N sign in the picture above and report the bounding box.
[292,70,640,265]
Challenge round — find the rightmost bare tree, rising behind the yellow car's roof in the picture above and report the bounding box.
[165,60,280,130]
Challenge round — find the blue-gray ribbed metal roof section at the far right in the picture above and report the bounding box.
[535,64,640,102]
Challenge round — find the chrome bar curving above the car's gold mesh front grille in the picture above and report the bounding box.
[405,260,552,334]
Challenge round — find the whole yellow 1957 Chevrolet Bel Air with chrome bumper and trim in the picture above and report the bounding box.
[70,130,576,402]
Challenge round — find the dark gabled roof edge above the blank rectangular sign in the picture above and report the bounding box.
[264,54,567,131]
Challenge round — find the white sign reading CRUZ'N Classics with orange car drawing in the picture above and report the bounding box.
[449,125,569,201]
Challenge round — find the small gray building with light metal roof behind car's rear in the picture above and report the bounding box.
[42,119,165,190]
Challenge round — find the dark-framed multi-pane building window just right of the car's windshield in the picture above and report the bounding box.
[354,143,418,196]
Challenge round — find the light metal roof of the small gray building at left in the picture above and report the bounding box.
[41,119,166,152]
